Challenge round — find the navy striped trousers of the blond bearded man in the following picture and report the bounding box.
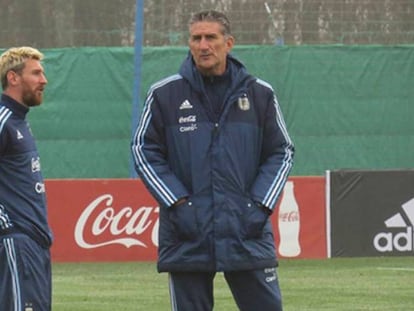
[0,233,52,311]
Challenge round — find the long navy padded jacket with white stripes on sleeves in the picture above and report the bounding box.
[132,55,294,272]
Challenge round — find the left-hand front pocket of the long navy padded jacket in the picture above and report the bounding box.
[170,199,199,241]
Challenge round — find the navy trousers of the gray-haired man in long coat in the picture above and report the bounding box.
[169,268,282,311]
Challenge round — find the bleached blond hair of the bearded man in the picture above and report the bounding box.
[0,46,44,90]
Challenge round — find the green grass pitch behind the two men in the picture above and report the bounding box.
[53,257,414,311]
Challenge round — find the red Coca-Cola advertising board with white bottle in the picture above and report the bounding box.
[46,177,327,262]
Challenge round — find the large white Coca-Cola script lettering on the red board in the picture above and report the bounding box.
[75,194,159,249]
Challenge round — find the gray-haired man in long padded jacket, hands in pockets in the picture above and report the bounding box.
[132,11,294,311]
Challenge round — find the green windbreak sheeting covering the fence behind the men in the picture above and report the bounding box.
[5,45,414,178]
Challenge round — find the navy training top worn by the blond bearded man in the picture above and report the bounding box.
[0,94,52,248]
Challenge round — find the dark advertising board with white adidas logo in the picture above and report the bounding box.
[327,170,414,257]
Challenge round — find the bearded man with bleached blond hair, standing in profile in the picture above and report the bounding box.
[0,47,52,311]
